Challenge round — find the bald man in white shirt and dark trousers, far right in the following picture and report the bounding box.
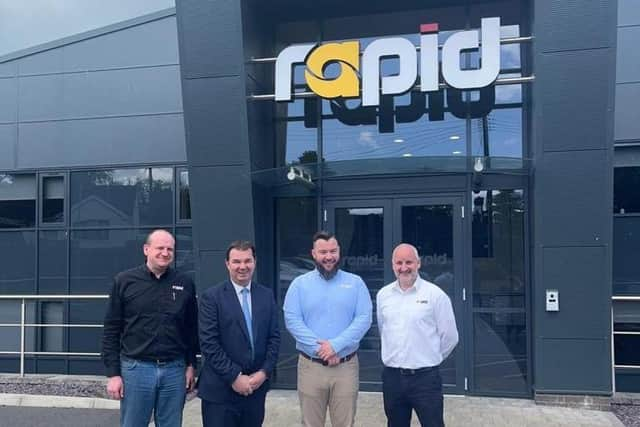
[376,243,458,427]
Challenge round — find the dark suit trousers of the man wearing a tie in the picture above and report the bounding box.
[202,387,267,427]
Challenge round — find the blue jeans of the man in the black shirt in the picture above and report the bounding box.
[120,358,186,427]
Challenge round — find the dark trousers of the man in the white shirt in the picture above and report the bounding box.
[382,366,444,427]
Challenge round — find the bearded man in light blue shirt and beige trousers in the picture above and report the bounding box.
[284,231,371,427]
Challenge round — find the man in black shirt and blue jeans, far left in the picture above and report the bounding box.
[102,230,198,427]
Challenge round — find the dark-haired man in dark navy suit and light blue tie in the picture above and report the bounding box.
[198,241,280,427]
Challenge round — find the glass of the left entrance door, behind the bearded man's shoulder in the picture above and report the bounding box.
[335,206,388,384]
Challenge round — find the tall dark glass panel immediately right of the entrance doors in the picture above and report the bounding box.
[471,190,528,394]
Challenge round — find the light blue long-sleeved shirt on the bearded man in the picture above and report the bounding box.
[283,270,372,357]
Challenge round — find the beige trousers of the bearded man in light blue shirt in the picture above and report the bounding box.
[298,355,360,427]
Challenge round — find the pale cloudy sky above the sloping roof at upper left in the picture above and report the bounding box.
[0,0,175,56]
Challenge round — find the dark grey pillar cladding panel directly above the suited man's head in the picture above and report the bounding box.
[189,166,254,250]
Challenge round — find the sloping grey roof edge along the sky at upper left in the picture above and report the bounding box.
[0,7,176,64]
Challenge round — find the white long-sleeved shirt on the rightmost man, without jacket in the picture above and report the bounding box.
[376,277,458,369]
